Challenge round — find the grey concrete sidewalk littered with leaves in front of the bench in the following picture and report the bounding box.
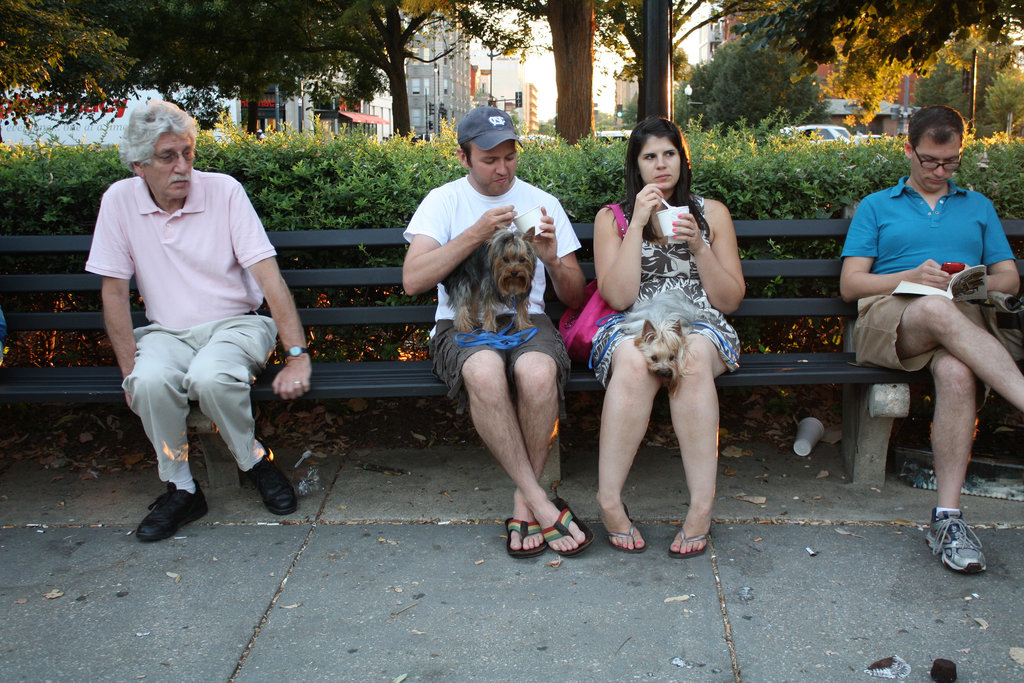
[0,443,1024,682]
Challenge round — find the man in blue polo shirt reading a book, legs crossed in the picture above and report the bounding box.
[840,106,1024,573]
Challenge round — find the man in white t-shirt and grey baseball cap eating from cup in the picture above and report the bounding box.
[402,106,593,557]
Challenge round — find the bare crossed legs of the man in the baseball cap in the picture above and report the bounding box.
[462,350,585,551]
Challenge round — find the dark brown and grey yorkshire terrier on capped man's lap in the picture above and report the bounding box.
[442,230,537,332]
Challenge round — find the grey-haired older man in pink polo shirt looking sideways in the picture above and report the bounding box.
[85,100,311,541]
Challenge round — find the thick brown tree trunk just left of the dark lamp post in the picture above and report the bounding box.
[548,0,595,142]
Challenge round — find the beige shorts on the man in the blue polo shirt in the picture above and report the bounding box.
[853,294,987,372]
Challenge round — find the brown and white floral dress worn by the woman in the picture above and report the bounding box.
[591,197,739,386]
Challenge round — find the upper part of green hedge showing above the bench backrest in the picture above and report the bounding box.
[0,118,1024,234]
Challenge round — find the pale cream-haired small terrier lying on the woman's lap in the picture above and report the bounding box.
[623,290,706,396]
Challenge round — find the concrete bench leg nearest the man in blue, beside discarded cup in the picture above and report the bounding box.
[843,384,910,486]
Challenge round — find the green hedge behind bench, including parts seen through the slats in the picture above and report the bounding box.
[0,127,1024,365]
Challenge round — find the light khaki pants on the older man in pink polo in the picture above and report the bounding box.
[122,315,278,481]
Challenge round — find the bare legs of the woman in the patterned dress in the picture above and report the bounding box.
[597,335,725,552]
